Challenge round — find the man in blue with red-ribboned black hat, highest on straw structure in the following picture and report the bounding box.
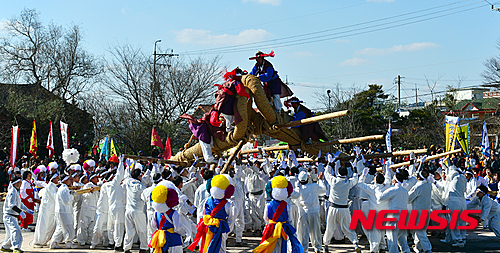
[249,51,283,113]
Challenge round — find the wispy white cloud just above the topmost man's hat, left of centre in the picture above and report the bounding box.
[175,29,272,46]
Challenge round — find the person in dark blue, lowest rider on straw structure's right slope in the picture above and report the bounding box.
[285,97,328,144]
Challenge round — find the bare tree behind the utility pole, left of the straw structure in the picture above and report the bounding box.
[106,45,223,125]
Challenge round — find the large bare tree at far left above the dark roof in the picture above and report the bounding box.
[0,9,102,101]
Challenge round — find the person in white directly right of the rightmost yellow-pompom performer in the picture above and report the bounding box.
[292,171,326,252]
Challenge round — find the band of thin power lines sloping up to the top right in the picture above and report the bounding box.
[185,0,484,54]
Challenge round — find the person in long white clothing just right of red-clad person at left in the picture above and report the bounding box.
[33,173,59,248]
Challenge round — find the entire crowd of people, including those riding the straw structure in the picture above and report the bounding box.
[0,52,500,253]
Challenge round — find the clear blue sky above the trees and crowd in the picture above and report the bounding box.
[0,0,500,108]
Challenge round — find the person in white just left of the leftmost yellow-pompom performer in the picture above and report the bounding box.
[123,169,148,253]
